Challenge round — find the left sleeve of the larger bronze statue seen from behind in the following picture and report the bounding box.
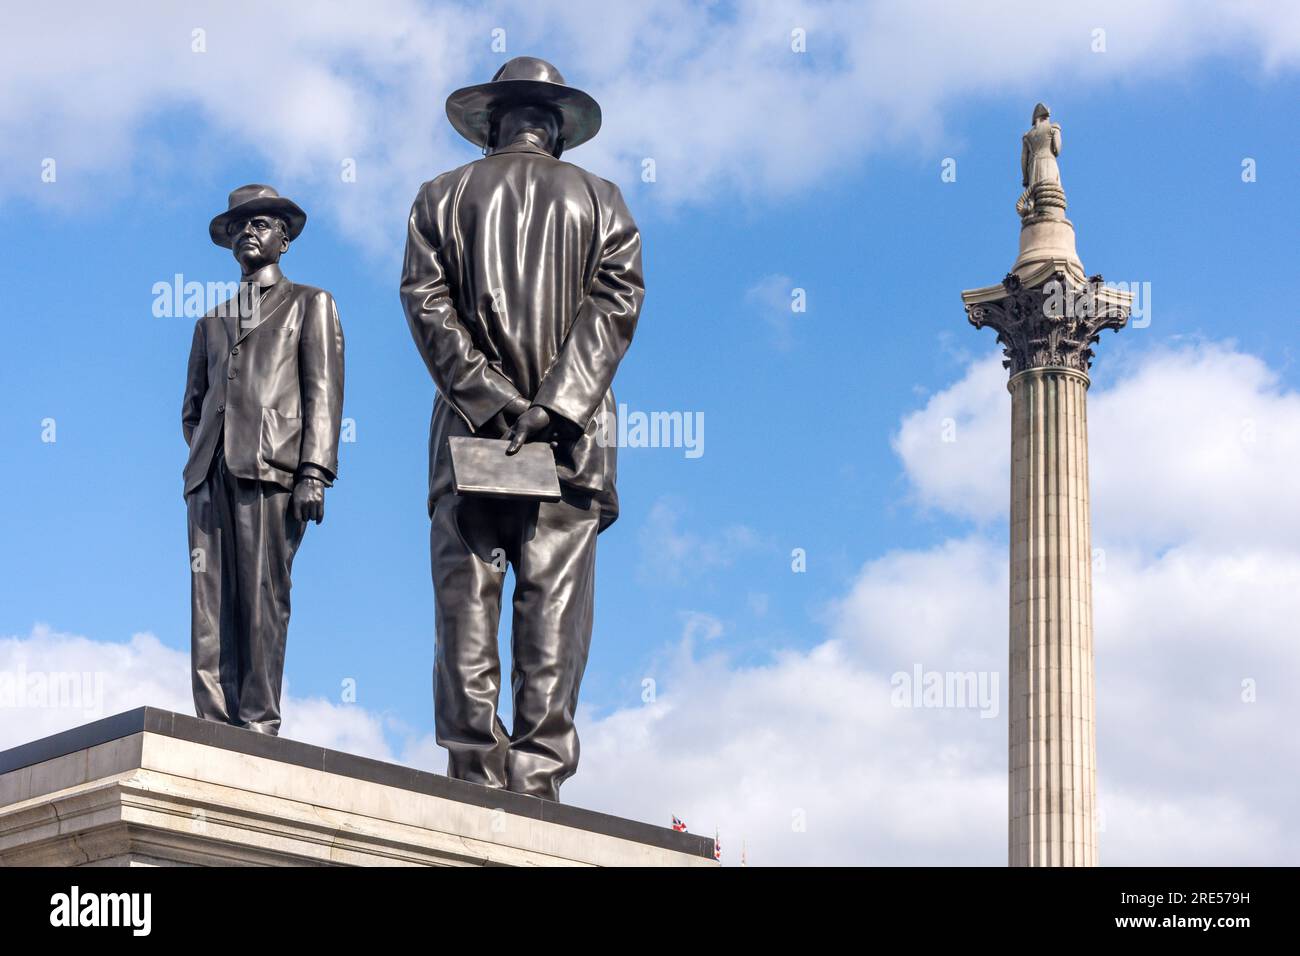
[402,187,519,432]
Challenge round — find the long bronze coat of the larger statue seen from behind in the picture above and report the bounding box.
[402,142,645,528]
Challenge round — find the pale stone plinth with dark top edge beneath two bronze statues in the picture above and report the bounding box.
[0,708,716,866]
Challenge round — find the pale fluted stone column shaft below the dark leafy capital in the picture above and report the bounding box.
[1008,367,1097,866]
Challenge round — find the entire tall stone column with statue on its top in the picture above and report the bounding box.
[962,103,1132,866]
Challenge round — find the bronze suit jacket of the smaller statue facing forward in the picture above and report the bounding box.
[181,271,343,494]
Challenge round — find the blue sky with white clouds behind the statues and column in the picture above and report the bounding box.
[0,4,1300,862]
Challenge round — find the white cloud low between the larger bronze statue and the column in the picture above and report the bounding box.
[566,540,1006,865]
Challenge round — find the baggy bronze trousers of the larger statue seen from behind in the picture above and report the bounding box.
[429,494,601,800]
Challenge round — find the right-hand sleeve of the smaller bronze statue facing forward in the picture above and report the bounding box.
[298,290,343,484]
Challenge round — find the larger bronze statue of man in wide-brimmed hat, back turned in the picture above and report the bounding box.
[402,57,645,800]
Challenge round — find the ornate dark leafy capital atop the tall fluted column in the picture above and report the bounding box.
[962,269,1132,375]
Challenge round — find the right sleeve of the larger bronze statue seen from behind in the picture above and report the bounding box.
[533,187,645,432]
